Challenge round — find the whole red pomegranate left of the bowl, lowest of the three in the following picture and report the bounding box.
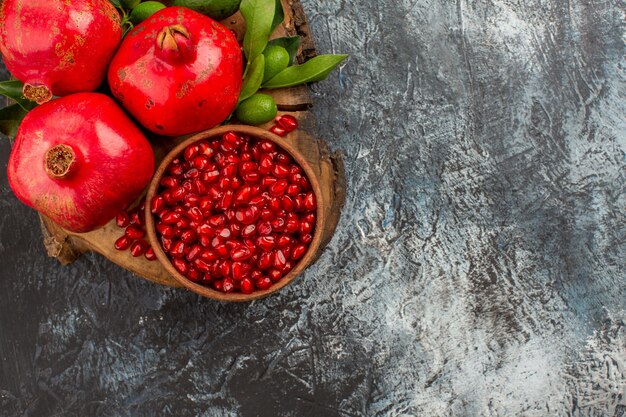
[7,93,154,233]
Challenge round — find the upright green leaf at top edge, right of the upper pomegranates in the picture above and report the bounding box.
[239,0,276,65]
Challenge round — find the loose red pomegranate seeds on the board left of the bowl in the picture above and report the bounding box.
[115,201,156,261]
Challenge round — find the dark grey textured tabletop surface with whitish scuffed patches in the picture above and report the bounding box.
[0,0,626,416]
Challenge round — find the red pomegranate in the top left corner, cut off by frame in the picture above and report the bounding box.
[0,0,122,104]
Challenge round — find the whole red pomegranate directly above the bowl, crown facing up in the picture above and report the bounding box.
[108,7,242,136]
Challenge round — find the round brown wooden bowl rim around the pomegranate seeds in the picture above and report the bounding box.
[146,125,326,301]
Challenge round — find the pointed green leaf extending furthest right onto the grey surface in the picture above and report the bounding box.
[263,55,348,88]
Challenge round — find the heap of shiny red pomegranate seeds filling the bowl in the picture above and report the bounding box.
[150,132,317,294]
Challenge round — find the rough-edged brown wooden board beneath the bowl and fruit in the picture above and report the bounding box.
[40,0,345,287]
